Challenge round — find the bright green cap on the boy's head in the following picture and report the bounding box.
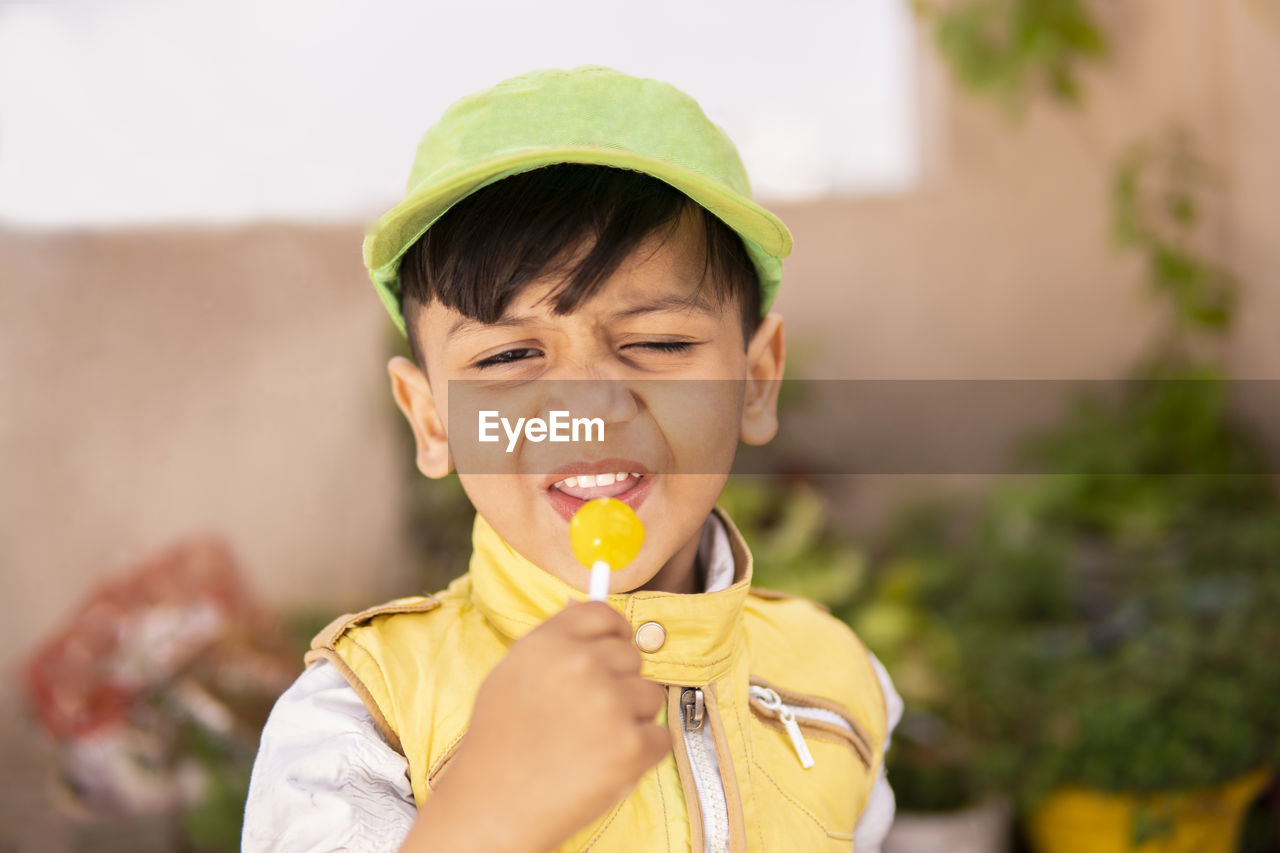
[365,65,791,333]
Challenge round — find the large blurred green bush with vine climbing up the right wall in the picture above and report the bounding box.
[851,131,1280,829]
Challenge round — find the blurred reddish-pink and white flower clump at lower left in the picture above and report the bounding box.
[24,537,298,813]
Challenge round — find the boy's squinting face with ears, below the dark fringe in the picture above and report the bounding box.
[388,216,785,592]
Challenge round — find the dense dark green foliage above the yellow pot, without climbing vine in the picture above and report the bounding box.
[867,378,1280,804]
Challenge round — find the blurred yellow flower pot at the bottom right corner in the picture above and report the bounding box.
[1028,767,1271,853]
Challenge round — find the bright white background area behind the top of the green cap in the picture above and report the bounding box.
[0,0,919,227]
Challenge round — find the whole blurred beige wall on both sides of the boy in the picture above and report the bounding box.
[0,0,1280,686]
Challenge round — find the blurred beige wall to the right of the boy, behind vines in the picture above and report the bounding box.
[777,0,1280,530]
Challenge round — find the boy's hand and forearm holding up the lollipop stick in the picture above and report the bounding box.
[402,602,671,850]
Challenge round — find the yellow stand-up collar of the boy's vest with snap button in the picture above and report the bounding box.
[470,507,751,686]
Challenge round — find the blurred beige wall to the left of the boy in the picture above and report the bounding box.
[0,227,407,665]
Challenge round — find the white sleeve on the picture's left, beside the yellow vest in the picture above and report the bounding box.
[241,661,417,853]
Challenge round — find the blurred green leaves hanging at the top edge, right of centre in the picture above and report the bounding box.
[913,0,1107,114]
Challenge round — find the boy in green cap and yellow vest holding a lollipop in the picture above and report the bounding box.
[244,67,901,852]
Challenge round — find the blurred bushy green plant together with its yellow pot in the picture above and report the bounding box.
[937,362,1280,852]
